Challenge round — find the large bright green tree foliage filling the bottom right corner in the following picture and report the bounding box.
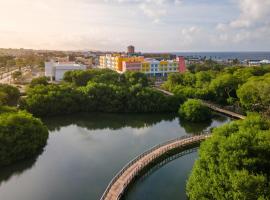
[187,115,270,200]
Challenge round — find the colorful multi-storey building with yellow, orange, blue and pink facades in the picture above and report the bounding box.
[99,54,186,77]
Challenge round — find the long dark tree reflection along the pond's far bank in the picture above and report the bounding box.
[43,113,175,131]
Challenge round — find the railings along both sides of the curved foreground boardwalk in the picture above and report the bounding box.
[100,131,210,200]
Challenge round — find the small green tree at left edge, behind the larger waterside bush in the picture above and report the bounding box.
[0,84,20,106]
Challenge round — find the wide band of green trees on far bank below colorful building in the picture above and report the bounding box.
[21,69,181,116]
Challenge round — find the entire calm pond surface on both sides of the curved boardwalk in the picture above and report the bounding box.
[0,114,229,200]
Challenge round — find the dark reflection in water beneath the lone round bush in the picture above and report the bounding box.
[179,114,228,134]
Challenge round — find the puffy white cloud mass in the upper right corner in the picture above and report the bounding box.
[206,0,270,50]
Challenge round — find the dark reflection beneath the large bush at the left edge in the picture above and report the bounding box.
[0,150,43,185]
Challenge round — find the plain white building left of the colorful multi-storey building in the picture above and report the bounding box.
[45,61,86,81]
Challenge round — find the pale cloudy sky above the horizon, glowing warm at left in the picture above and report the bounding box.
[0,0,270,52]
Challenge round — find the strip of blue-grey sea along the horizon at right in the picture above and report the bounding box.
[173,51,270,61]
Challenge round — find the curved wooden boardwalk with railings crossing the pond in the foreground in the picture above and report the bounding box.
[101,134,210,200]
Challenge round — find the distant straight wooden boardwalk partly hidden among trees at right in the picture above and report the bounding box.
[155,87,246,119]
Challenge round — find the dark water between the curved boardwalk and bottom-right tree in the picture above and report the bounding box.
[126,152,198,200]
